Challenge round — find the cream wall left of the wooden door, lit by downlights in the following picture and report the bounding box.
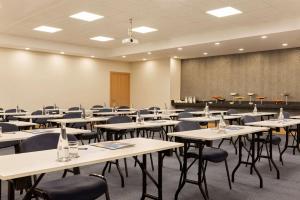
[0,48,130,110]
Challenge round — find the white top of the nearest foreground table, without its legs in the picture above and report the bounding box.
[0,138,183,180]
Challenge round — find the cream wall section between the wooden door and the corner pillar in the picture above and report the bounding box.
[131,59,170,108]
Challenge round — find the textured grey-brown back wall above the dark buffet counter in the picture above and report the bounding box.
[181,49,300,101]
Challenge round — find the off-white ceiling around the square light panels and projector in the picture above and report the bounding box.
[0,0,300,61]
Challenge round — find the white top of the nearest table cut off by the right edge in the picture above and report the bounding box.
[246,119,300,128]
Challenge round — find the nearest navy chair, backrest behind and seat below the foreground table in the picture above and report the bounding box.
[20,133,110,200]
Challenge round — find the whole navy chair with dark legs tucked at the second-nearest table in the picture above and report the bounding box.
[174,121,231,195]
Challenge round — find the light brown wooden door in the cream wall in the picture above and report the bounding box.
[110,72,130,106]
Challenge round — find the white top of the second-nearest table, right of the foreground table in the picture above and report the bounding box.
[168,125,269,141]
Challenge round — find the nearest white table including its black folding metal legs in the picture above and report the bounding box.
[0,138,183,200]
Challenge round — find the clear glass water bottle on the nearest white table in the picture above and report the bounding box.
[57,124,70,162]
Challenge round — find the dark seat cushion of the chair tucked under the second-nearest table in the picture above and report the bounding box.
[202,147,228,162]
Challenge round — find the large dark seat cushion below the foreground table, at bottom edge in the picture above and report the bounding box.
[37,175,107,200]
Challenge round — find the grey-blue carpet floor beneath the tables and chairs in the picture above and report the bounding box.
[0,135,300,200]
